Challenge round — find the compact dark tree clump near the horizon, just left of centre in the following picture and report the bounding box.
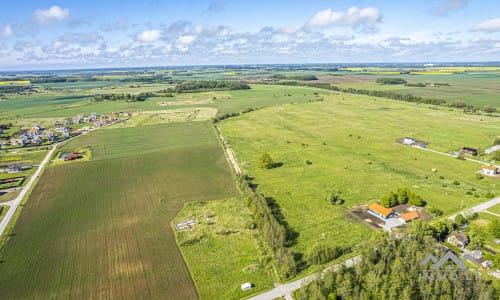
[174,80,250,93]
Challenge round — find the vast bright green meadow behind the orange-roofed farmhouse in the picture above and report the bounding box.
[220,95,500,264]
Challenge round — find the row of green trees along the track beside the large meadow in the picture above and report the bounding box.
[240,176,297,279]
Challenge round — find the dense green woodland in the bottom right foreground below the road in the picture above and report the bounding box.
[299,221,498,300]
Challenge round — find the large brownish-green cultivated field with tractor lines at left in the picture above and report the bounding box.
[0,122,238,299]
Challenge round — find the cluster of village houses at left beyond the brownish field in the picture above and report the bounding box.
[0,112,131,149]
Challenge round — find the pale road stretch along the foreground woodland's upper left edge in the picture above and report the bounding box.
[249,256,361,300]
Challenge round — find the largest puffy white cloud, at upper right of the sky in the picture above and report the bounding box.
[307,6,382,27]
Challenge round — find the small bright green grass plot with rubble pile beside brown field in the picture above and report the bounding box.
[172,198,272,299]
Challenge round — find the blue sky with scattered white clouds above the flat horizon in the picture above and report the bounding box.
[0,0,500,71]
